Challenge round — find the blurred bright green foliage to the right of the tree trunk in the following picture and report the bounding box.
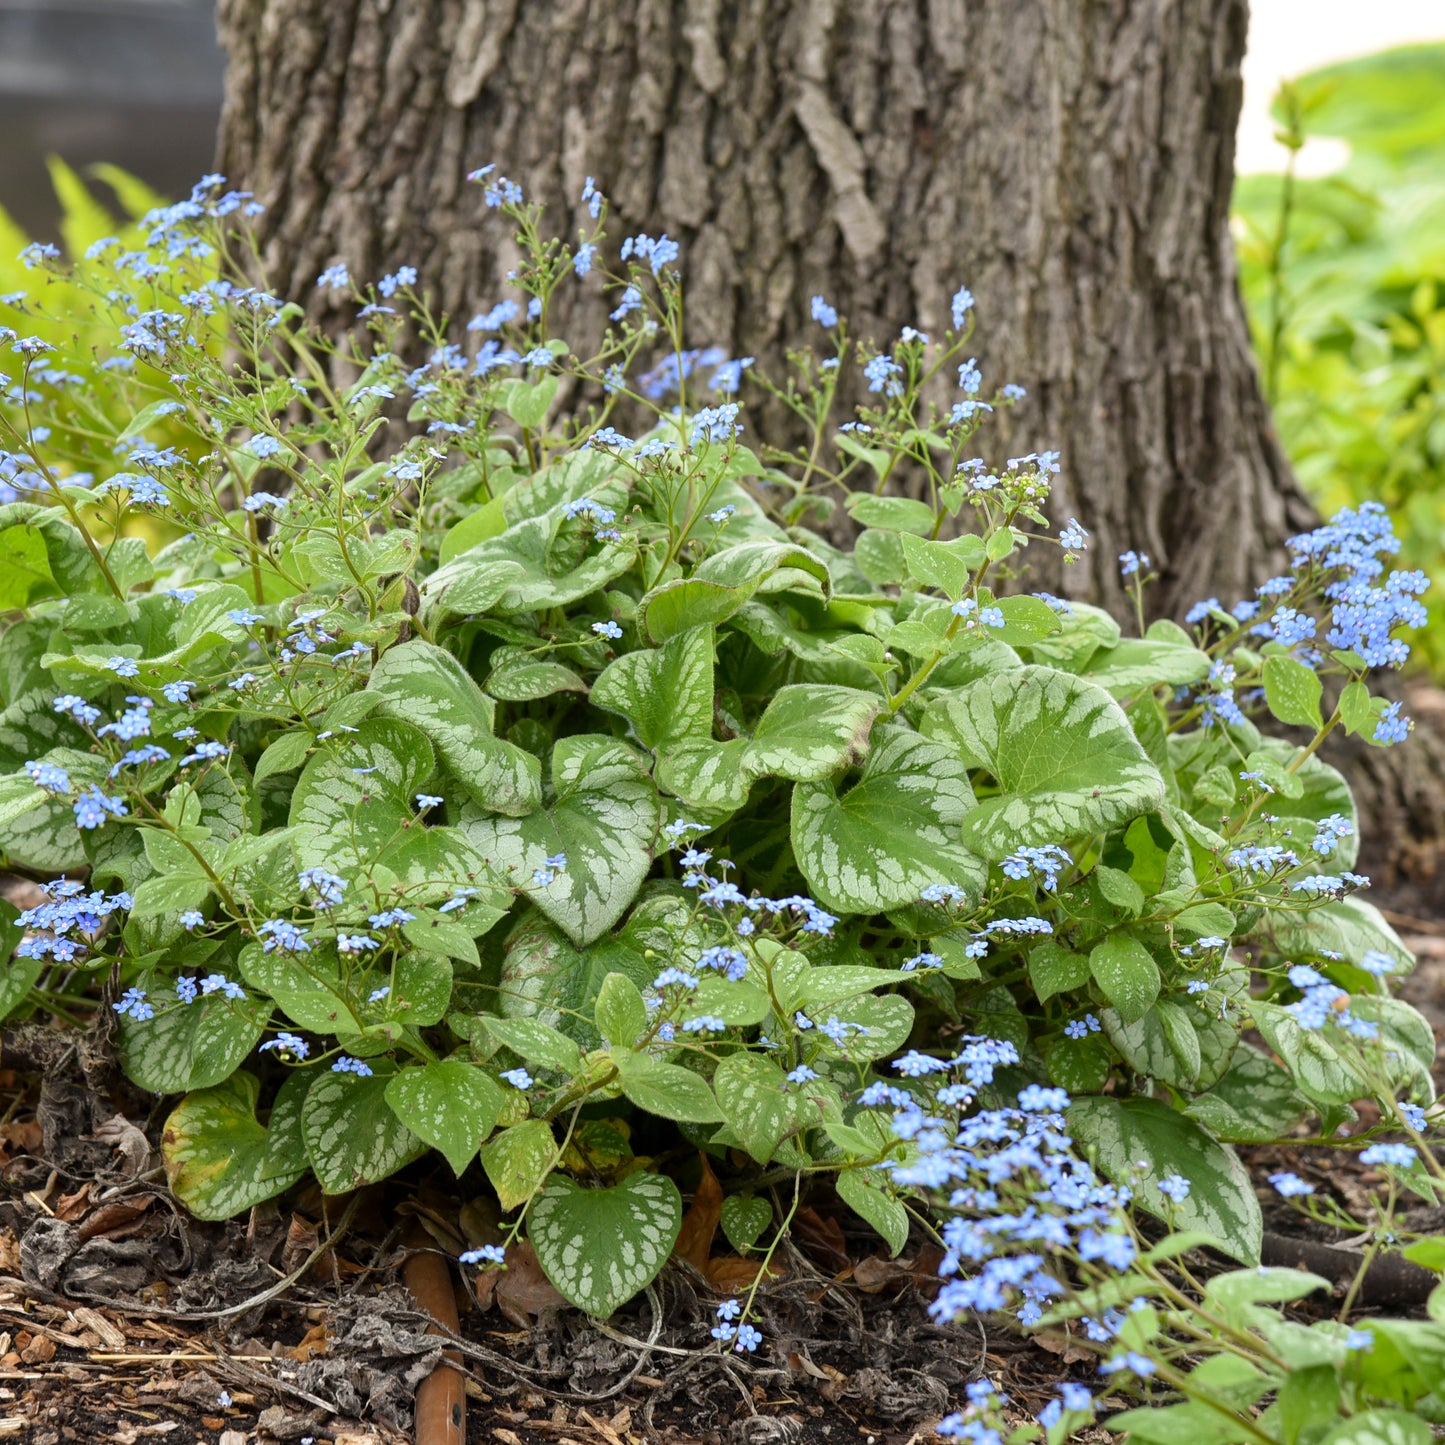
[1234,43,1445,676]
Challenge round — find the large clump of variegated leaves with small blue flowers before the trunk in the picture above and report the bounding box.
[0,168,1435,1441]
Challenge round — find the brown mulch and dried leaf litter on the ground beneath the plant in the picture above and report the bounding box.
[0,895,1445,1445]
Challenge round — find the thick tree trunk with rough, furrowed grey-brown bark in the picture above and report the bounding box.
[218,0,1441,895]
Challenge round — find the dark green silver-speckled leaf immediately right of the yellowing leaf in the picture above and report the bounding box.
[301,1062,426,1194]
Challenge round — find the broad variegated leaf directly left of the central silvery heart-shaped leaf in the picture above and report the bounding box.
[289,718,434,873]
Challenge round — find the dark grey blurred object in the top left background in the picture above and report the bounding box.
[0,0,224,240]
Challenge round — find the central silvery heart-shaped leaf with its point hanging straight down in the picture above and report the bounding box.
[460,734,657,945]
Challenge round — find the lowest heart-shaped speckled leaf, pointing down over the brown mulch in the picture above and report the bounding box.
[527,1173,682,1319]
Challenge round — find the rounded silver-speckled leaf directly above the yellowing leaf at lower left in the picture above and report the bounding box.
[118,978,269,1094]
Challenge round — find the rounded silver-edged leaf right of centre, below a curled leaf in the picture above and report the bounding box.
[792,727,987,913]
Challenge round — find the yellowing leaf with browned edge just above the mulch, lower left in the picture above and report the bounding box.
[160,1069,309,1220]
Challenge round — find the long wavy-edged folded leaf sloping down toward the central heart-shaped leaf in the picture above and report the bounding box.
[367,639,542,816]
